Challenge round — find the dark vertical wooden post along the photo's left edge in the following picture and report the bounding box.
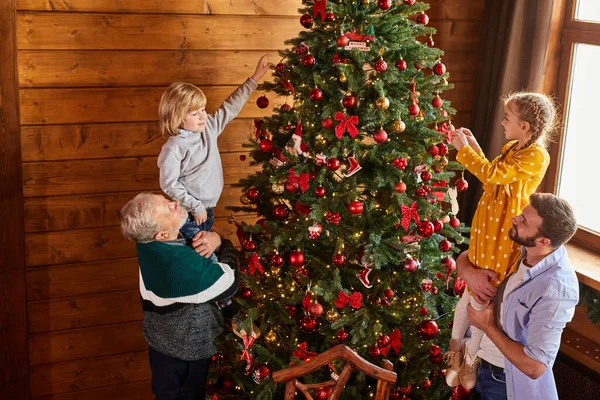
[0,0,29,399]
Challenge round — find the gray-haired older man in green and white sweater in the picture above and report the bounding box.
[121,193,239,400]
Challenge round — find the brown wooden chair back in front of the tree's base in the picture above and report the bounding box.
[273,344,397,400]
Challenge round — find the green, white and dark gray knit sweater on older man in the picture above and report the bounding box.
[136,239,239,361]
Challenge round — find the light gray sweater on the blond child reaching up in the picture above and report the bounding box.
[158,78,257,215]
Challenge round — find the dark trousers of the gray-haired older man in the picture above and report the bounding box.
[149,347,210,400]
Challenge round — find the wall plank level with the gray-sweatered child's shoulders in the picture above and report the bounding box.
[21,118,254,161]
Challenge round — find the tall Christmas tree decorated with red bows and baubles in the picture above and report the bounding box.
[209,0,466,399]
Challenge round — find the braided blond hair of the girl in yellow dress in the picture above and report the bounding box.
[502,92,558,158]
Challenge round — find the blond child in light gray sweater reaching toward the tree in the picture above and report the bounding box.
[158,55,271,256]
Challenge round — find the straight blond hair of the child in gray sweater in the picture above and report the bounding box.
[158,82,206,139]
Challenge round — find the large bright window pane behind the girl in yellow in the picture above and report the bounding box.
[558,43,600,232]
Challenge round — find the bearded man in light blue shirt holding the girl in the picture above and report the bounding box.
[458,193,579,400]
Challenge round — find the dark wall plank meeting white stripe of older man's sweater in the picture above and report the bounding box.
[27,290,142,332]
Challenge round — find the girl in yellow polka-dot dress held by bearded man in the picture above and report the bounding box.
[446,92,556,389]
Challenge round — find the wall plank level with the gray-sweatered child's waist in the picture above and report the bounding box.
[23,153,257,197]
